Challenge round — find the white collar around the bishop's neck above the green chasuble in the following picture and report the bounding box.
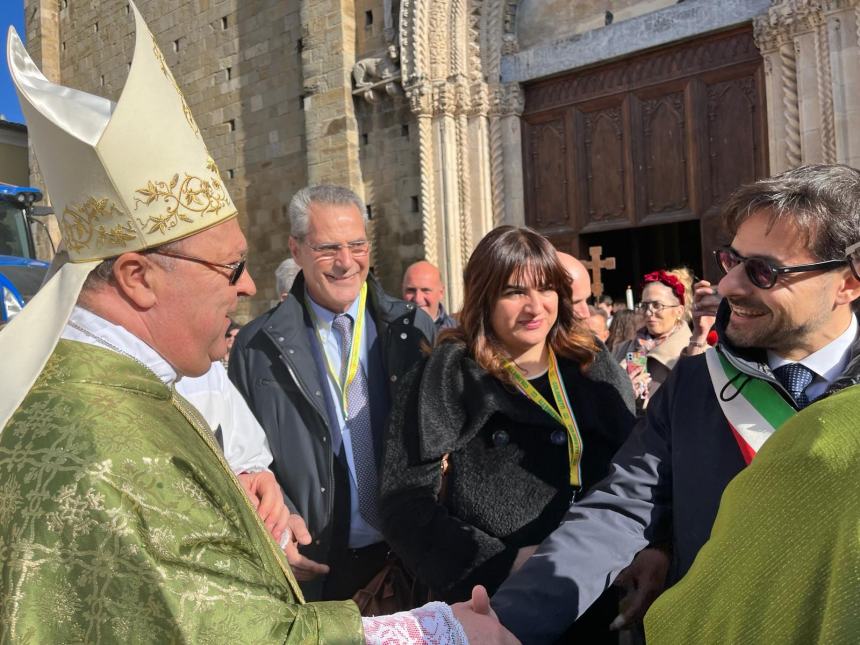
[60,306,178,385]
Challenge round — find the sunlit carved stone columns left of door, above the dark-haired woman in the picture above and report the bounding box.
[400,0,522,311]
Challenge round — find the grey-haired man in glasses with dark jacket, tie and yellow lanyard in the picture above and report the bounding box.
[230,185,435,599]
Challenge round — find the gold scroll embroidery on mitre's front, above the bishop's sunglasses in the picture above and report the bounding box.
[134,170,229,235]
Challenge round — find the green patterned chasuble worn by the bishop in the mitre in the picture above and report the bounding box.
[0,340,364,644]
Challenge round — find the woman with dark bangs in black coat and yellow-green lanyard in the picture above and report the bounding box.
[381,226,634,643]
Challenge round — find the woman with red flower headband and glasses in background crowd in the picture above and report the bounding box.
[615,269,692,411]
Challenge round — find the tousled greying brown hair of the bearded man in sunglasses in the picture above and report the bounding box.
[723,164,860,261]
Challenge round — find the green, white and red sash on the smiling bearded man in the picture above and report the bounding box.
[705,350,797,464]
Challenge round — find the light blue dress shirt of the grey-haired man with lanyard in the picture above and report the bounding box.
[306,294,382,549]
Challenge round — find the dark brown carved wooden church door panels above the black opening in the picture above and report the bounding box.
[523,26,767,277]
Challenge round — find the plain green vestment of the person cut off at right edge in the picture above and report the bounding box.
[645,385,860,645]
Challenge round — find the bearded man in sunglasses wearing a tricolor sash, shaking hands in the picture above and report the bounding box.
[493,165,860,643]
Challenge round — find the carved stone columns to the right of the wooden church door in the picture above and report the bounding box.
[755,0,860,173]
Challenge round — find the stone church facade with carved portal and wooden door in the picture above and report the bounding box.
[25,0,860,317]
